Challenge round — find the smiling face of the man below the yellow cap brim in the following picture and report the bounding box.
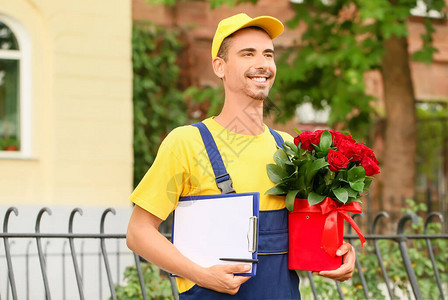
[219,28,277,100]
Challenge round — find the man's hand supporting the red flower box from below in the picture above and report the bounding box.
[313,243,356,282]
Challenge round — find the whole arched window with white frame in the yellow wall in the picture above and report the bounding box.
[0,15,31,158]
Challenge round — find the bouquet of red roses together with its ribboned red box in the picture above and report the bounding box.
[266,130,379,271]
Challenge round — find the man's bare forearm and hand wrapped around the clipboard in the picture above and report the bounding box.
[126,205,250,295]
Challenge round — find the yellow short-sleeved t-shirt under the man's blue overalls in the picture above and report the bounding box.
[130,118,293,292]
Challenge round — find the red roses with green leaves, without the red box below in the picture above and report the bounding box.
[266,130,380,211]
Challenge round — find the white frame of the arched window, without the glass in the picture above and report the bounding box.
[0,13,32,159]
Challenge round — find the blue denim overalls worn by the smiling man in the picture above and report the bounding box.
[180,123,300,300]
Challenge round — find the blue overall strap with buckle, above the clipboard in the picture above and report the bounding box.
[193,122,235,194]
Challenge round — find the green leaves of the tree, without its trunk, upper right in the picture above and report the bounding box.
[276,0,444,137]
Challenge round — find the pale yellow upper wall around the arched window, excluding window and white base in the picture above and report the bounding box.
[0,0,132,206]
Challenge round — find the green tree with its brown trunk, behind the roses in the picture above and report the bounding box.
[147,0,446,216]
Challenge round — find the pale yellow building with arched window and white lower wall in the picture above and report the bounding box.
[0,0,133,299]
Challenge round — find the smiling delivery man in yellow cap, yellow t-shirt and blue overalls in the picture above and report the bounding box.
[127,14,355,299]
